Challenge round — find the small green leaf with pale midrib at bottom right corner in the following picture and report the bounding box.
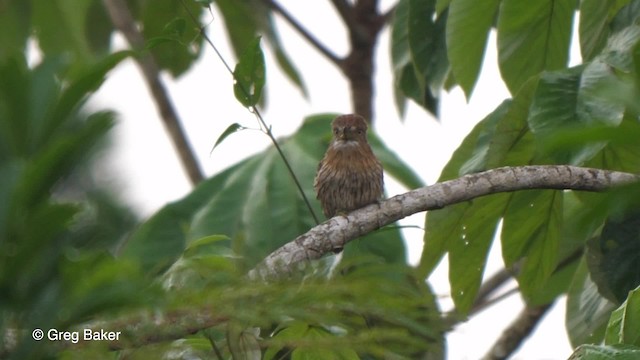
[604,288,640,346]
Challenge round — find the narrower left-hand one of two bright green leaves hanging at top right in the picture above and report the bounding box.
[446,0,500,99]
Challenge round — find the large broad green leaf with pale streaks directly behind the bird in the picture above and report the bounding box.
[124,115,421,272]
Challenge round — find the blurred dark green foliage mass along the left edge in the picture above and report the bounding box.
[0,53,143,358]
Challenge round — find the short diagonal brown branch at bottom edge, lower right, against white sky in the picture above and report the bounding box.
[484,303,553,360]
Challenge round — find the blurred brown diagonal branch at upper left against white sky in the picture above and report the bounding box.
[103,0,204,185]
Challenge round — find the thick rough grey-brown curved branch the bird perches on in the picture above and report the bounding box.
[249,165,640,278]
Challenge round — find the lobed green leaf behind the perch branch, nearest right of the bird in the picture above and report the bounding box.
[418,108,510,313]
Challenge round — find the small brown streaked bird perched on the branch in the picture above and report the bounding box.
[313,114,384,218]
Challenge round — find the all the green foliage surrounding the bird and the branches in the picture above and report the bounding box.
[0,0,640,359]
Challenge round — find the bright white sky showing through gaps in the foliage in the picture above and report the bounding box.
[91,0,571,360]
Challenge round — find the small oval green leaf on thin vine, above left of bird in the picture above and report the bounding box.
[233,37,266,107]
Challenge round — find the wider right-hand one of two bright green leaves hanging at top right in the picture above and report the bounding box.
[498,0,576,94]
